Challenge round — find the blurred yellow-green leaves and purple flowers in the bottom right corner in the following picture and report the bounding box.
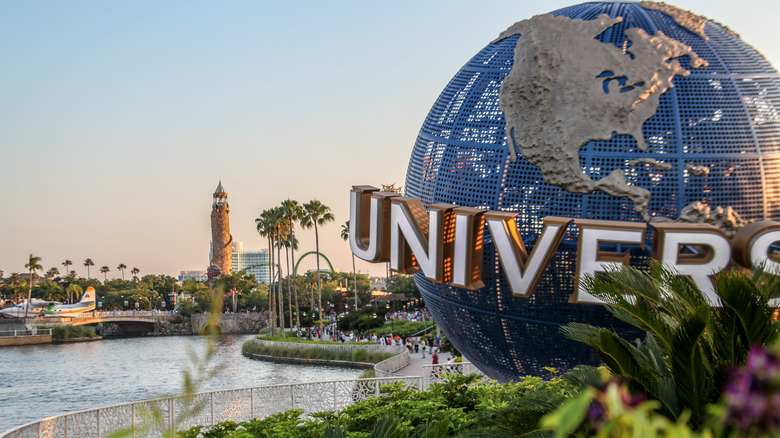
[541,346,780,438]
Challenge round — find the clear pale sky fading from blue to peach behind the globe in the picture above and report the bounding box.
[0,0,780,278]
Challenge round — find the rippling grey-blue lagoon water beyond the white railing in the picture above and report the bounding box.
[0,335,361,432]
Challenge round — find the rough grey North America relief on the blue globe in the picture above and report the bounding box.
[499,14,707,221]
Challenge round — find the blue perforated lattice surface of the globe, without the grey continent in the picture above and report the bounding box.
[405,2,780,381]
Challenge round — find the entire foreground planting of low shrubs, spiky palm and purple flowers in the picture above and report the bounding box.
[172,265,780,438]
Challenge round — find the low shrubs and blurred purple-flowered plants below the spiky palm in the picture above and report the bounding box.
[179,348,780,438]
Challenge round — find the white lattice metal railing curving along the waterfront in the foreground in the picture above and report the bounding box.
[0,377,422,438]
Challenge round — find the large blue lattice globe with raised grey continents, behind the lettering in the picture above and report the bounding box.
[405,2,780,381]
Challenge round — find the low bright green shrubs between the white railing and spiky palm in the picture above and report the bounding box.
[180,375,584,438]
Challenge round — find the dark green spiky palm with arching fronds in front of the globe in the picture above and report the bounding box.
[563,262,780,428]
